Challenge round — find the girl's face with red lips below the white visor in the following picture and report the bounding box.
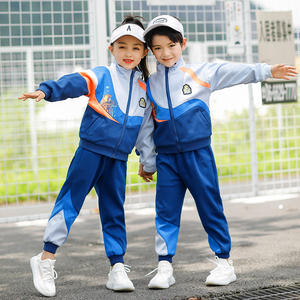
[108,35,148,70]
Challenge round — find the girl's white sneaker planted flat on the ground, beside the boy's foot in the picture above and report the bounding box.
[106,263,135,291]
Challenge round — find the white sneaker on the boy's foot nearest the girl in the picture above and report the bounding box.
[148,260,175,289]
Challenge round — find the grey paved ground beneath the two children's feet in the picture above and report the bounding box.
[0,195,300,300]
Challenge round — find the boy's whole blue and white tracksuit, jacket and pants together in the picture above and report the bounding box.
[147,57,272,261]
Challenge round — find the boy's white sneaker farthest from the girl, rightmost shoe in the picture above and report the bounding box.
[205,256,236,285]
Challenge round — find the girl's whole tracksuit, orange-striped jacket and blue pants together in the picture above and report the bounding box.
[38,61,156,265]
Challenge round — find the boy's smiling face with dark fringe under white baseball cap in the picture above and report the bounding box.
[151,34,186,67]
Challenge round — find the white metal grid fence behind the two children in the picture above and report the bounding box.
[0,0,300,221]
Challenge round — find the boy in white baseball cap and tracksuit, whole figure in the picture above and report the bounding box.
[141,15,297,288]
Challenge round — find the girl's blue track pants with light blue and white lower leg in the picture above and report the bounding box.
[44,147,127,265]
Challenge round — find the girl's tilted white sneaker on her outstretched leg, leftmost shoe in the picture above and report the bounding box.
[30,253,57,297]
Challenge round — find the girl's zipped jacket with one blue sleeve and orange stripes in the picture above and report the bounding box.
[38,61,155,172]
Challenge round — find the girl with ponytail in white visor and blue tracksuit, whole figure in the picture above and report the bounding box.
[19,17,156,297]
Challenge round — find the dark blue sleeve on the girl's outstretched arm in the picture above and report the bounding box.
[37,73,89,102]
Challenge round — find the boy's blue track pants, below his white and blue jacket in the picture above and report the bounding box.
[155,146,231,261]
